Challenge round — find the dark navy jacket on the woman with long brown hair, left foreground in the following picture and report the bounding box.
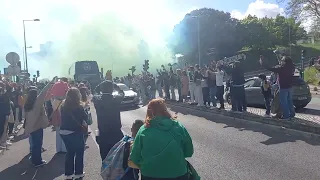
[60,106,88,132]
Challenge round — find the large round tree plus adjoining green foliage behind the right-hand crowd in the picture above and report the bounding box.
[169,8,306,71]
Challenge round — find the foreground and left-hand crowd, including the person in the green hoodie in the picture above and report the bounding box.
[0,74,193,180]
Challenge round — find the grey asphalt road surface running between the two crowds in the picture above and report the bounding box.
[0,107,320,180]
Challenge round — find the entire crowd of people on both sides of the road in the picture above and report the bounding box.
[0,51,295,180]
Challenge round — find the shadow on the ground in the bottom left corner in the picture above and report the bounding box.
[0,154,64,180]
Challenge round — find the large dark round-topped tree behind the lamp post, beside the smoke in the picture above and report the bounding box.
[168,8,243,64]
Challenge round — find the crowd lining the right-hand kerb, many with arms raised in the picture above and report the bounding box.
[114,55,295,119]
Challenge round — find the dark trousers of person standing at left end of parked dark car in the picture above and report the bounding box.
[230,86,247,112]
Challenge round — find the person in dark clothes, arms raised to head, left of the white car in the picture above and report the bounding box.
[92,80,123,161]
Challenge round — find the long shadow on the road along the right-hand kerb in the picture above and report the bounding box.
[169,105,320,146]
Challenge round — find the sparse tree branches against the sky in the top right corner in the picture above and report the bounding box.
[279,0,320,19]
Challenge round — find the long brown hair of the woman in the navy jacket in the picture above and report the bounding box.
[62,87,81,111]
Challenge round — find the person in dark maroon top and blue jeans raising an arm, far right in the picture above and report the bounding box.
[260,56,295,119]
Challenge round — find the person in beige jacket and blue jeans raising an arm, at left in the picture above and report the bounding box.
[24,77,56,167]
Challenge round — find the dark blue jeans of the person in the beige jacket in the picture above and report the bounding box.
[30,129,43,166]
